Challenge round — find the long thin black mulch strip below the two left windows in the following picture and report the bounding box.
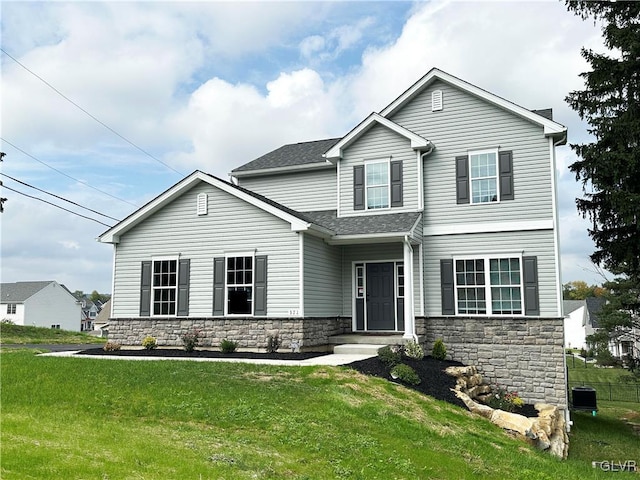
[78,348,328,360]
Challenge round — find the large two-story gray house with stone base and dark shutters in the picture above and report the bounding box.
[99,69,566,406]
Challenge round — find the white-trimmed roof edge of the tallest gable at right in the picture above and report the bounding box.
[380,68,567,142]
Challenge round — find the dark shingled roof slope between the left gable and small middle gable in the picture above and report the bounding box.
[231,138,340,177]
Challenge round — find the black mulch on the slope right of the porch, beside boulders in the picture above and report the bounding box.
[346,356,538,417]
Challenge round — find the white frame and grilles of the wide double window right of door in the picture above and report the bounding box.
[453,253,525,317]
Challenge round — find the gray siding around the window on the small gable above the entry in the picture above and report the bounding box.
[339,125,418,217]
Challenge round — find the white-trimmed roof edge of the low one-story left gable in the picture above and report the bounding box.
[98,170,331,243]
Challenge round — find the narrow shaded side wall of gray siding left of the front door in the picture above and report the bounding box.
[304,235,342,317]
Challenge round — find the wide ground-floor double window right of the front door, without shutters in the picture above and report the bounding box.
[454,257,523,315]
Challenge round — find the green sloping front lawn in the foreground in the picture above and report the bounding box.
[0,349,640,480]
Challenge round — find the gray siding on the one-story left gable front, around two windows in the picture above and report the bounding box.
[112,182,299,317]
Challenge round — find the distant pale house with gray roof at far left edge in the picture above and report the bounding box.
[0,281,81,332]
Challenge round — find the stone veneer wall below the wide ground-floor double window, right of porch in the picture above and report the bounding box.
[416,317,567,408]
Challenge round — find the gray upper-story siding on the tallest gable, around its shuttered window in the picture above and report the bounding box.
[390,81,552,228]
